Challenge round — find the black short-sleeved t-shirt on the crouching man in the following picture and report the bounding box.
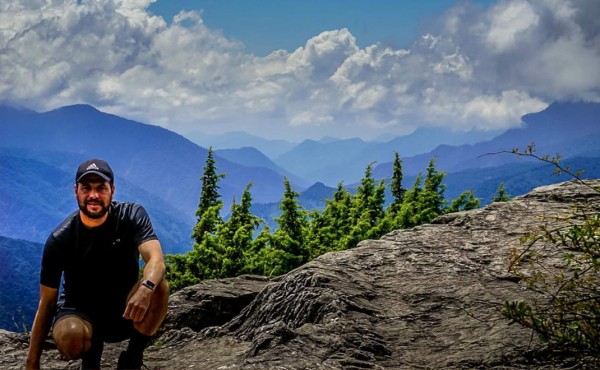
[40,202,157,317]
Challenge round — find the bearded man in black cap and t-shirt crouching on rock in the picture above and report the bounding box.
[26,159,169,369]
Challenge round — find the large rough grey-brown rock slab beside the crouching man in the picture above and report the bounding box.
[0,181,600,369]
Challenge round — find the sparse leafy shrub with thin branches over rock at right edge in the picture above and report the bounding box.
[503,145,600,355]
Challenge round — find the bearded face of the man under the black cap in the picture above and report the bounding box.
[75,175,114,219]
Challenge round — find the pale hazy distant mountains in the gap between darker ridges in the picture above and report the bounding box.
[187,127,502,186]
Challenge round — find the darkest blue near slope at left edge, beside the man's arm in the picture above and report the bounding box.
[0,236,43,332]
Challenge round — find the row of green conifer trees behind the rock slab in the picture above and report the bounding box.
[166,150,486,291]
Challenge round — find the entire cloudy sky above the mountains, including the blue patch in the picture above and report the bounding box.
[0,0,600,141]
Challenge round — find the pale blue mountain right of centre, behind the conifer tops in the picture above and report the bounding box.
[275,128,499,186]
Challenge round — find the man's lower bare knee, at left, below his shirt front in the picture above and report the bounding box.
[52,316,92,359]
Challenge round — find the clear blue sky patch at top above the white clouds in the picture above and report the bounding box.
[148,0,496,56]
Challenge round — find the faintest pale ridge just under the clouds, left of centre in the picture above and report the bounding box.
[185,130,297,158]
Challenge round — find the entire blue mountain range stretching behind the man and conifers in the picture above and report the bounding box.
[0,102,600,253]
